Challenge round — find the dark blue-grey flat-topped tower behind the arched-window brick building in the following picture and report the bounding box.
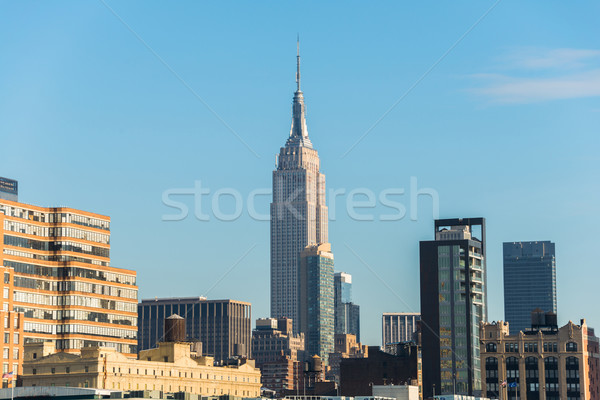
[503,241,557,332]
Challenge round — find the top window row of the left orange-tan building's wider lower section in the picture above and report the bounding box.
[4,260,136,285]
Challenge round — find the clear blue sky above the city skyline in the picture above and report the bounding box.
[0,0,600,344]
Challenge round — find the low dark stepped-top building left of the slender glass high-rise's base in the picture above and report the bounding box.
[252,318,304,368]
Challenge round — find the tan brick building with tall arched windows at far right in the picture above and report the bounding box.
[481,310,600,400]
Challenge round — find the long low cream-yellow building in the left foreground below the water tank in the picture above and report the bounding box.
[23,342,261,397]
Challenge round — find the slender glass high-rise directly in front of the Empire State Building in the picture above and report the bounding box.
[298,243,334,364]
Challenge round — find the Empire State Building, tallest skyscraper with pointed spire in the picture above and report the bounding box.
[271,46,327,332]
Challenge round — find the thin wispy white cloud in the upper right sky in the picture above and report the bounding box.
[471,49,600,103]
